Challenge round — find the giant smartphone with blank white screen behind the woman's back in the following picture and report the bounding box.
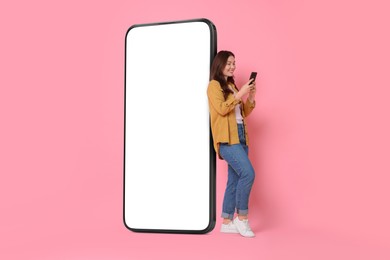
[123,19,217,233]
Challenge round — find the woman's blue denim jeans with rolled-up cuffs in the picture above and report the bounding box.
[219,124,255,219]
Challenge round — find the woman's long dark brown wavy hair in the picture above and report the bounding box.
[210,51,235,99]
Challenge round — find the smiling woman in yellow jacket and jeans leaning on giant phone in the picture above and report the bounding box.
[207,51,256,237]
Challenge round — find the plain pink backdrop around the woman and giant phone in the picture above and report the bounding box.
[0,0,390,259]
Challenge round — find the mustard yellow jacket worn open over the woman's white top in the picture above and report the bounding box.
[207,80,255,159]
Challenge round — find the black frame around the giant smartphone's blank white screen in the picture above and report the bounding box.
[123,18,217,234]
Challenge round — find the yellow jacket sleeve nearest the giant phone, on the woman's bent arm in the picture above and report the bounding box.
[207,80,241,116]
